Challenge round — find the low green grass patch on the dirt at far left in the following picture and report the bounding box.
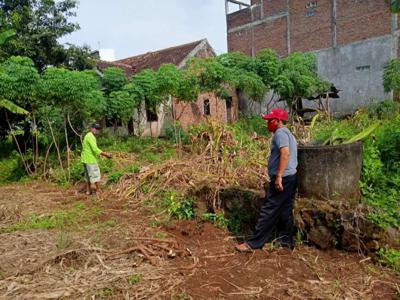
[0,203,102,232]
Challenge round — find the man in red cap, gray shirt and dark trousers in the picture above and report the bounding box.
[235,108,297,252]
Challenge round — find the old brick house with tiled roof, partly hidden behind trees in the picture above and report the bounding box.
[98,39,238,136]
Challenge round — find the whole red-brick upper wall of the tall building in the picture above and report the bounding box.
[227,0,391,55]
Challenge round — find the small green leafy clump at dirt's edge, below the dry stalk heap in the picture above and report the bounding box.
[165,191,195,220]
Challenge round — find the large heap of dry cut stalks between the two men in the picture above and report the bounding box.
[117,120,270,210]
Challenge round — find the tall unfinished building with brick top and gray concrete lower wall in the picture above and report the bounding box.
[226,0,400,114]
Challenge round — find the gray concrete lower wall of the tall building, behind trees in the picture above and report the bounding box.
[315,35,393,114]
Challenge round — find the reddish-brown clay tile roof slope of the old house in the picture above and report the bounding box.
[113,40,204,73]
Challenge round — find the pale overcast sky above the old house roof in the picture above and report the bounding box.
[61,0,231,59]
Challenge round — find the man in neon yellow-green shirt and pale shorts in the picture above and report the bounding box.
[81,123,111,195]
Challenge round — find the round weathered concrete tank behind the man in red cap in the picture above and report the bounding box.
[298,142,363,200]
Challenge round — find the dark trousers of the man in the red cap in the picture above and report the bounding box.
[247,175,297,249]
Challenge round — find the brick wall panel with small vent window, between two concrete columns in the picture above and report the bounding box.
[290,0,332,52]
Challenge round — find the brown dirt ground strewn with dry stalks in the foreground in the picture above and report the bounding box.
[0,183,400,300]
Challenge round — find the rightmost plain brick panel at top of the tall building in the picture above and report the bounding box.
[337,0,391,45]
